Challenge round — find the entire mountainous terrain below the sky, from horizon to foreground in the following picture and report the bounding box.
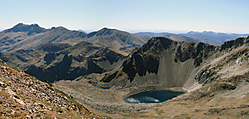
[0,23,249,119]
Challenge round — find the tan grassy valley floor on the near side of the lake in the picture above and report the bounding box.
[53,79,249,119]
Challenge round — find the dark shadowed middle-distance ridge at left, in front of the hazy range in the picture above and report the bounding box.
[1,41,127,82]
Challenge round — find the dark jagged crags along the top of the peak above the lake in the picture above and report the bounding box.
[122,37,215,79]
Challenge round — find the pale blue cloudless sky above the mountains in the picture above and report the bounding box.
[0,0,249,33]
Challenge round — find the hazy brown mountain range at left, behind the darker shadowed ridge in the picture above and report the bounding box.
[0,23,149,52]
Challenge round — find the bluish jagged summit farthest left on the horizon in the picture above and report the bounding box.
[5,23,45,35]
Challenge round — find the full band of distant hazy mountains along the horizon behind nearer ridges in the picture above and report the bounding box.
[0,23,247,53]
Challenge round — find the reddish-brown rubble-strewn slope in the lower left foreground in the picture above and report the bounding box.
[0,61,106,119]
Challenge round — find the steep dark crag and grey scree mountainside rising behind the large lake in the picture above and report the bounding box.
[100,37,249,91]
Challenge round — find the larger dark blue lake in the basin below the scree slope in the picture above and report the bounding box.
[126,90,183,103]
